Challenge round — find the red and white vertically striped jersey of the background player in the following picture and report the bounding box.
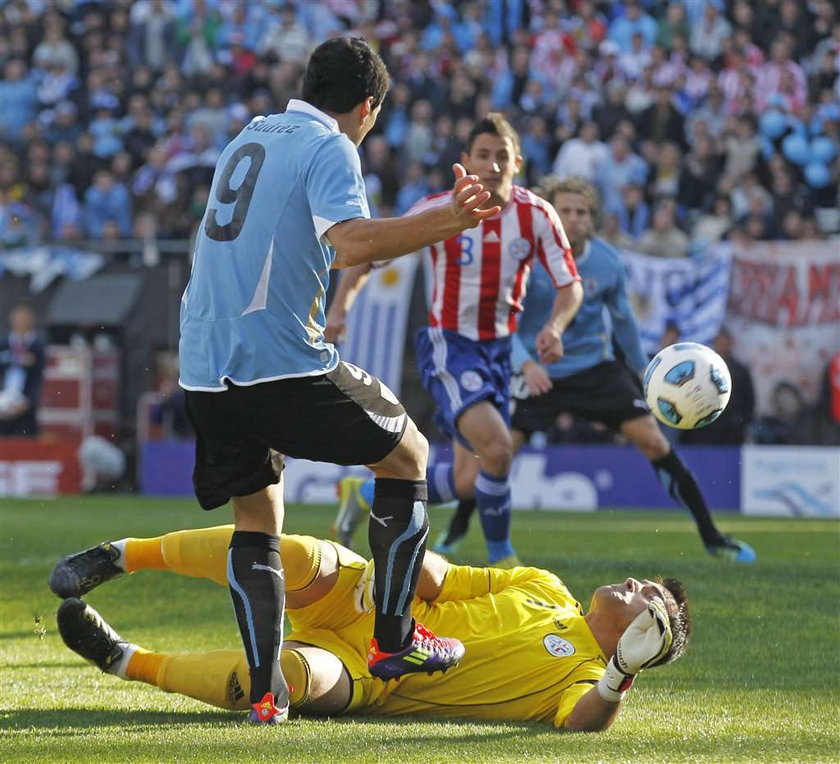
[408,186,579,340]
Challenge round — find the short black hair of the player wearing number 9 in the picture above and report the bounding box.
[302,37,391,114]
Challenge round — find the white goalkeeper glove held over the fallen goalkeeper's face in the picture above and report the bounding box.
[598,597,673,703]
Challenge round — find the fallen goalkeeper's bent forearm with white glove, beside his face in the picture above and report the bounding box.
[564,599,673,732]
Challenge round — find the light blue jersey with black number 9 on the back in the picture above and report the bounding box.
[179,100,370,391]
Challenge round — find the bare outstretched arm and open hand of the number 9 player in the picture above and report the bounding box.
[326,163,501,268]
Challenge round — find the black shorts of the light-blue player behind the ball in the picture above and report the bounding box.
[511,361,650,435]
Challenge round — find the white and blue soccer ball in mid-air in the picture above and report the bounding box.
[642,342,732,430]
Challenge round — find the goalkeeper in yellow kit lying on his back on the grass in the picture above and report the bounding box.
[50,526,691,731]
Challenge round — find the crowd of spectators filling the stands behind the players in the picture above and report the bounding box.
[0,0,840,257]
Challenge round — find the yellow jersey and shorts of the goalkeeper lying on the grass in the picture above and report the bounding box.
[288,547,606,727]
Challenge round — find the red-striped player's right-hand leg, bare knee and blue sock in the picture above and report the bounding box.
[456,400,519,565]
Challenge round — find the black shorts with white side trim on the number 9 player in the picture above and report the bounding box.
[186,361,408,509]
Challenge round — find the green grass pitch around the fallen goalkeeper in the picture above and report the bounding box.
[0,496,840,763]
